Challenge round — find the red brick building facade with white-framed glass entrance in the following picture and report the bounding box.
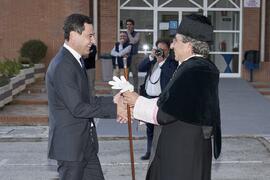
[0,0,270,81]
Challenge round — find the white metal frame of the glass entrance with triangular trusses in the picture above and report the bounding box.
[117,0,243,78]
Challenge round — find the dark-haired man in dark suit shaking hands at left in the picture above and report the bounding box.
[46,14,116,180]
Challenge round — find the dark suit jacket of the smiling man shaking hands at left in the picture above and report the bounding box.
[46,47,116,161]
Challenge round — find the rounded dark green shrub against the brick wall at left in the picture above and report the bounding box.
[20,40,48,64]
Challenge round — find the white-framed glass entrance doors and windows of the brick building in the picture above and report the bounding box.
[118,0,243,77]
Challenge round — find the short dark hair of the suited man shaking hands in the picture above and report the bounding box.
[63,14,93,40]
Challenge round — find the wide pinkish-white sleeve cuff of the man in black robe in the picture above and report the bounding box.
[133,96,158,125]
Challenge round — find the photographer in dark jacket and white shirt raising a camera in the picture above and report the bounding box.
[139,39,178,160]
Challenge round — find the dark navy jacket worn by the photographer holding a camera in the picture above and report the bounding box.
[139,56,178,93]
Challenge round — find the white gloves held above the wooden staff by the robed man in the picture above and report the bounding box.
[109,76,134,93]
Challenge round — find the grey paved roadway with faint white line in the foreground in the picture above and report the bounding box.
[0,137,270,180]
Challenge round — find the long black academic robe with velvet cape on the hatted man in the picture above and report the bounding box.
[146,56,221,180]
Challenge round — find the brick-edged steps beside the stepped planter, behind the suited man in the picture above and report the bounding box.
[0,80,112,125]
